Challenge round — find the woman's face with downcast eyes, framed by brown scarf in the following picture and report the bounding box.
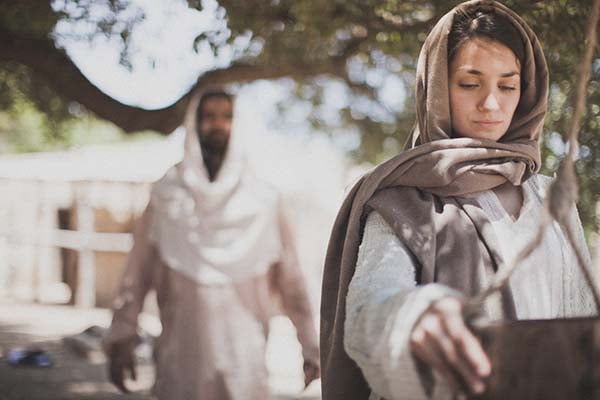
[449,38,521,141]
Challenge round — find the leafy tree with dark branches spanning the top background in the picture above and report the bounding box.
[0,0,600,228]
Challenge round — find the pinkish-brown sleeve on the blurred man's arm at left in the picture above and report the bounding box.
[103,205,159,349]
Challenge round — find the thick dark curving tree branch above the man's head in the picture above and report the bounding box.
[0,30,346,134]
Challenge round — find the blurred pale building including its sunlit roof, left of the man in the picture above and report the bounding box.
[0,137,181,307]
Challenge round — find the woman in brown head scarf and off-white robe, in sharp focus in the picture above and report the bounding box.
[321,0,596,400]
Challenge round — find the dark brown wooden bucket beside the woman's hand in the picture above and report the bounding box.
[476,318,600,400]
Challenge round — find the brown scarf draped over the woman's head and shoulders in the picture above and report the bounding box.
[321,0,548,400]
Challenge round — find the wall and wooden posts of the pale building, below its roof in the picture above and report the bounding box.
[0,180,150,307]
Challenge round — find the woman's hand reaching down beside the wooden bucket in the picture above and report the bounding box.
[410,297,492,394]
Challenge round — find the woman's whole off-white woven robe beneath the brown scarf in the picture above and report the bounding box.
[344,175,596,400]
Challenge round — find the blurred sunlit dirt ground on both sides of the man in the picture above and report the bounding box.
[0,303,320,400]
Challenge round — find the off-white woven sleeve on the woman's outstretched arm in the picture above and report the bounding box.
[344,212,458,400]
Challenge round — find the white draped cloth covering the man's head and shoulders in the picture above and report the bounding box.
[150,89,281,285]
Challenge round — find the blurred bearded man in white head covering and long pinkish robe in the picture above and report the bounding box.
[104,91,320,400]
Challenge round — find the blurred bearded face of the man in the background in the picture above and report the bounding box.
[198,97,233,151]
